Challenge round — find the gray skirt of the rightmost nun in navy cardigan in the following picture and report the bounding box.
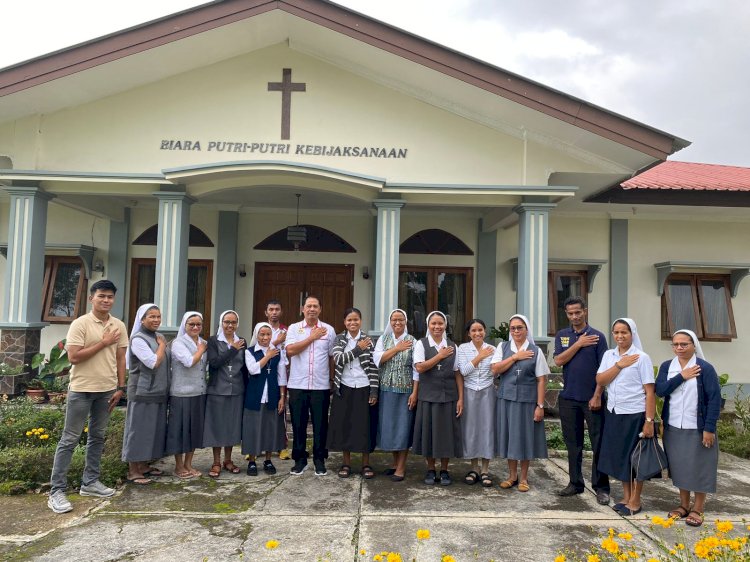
[664,425,719,494]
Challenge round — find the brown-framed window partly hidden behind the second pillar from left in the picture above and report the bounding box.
[127,258,214,339]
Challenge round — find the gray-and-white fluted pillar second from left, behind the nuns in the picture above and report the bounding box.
[154,191,194,334]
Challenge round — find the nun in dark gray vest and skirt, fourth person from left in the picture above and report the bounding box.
[203,310,247,478]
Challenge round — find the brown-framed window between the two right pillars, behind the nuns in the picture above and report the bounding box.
[398,266,474,343]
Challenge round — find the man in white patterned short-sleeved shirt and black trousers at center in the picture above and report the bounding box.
[286,295,336,476]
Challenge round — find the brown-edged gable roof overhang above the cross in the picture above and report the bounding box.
[0,0,690,163]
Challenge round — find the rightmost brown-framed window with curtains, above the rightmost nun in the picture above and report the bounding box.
[661,273,737,341]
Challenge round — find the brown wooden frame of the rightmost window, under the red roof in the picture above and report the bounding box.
[661,273,737,342]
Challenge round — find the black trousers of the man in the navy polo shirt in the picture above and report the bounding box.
[557,397,609,493]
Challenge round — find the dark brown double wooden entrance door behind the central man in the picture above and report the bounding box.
[253,262,354,332]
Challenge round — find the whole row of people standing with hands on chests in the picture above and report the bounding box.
[48,281,720,526]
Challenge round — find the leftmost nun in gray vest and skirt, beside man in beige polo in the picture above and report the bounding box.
[122,303,170,484]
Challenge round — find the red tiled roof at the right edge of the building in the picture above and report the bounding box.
[620,161,750,191]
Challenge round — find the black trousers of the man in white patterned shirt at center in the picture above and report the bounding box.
[289,388,331,461]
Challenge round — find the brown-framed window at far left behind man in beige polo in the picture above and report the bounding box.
[42,256,86,323]
